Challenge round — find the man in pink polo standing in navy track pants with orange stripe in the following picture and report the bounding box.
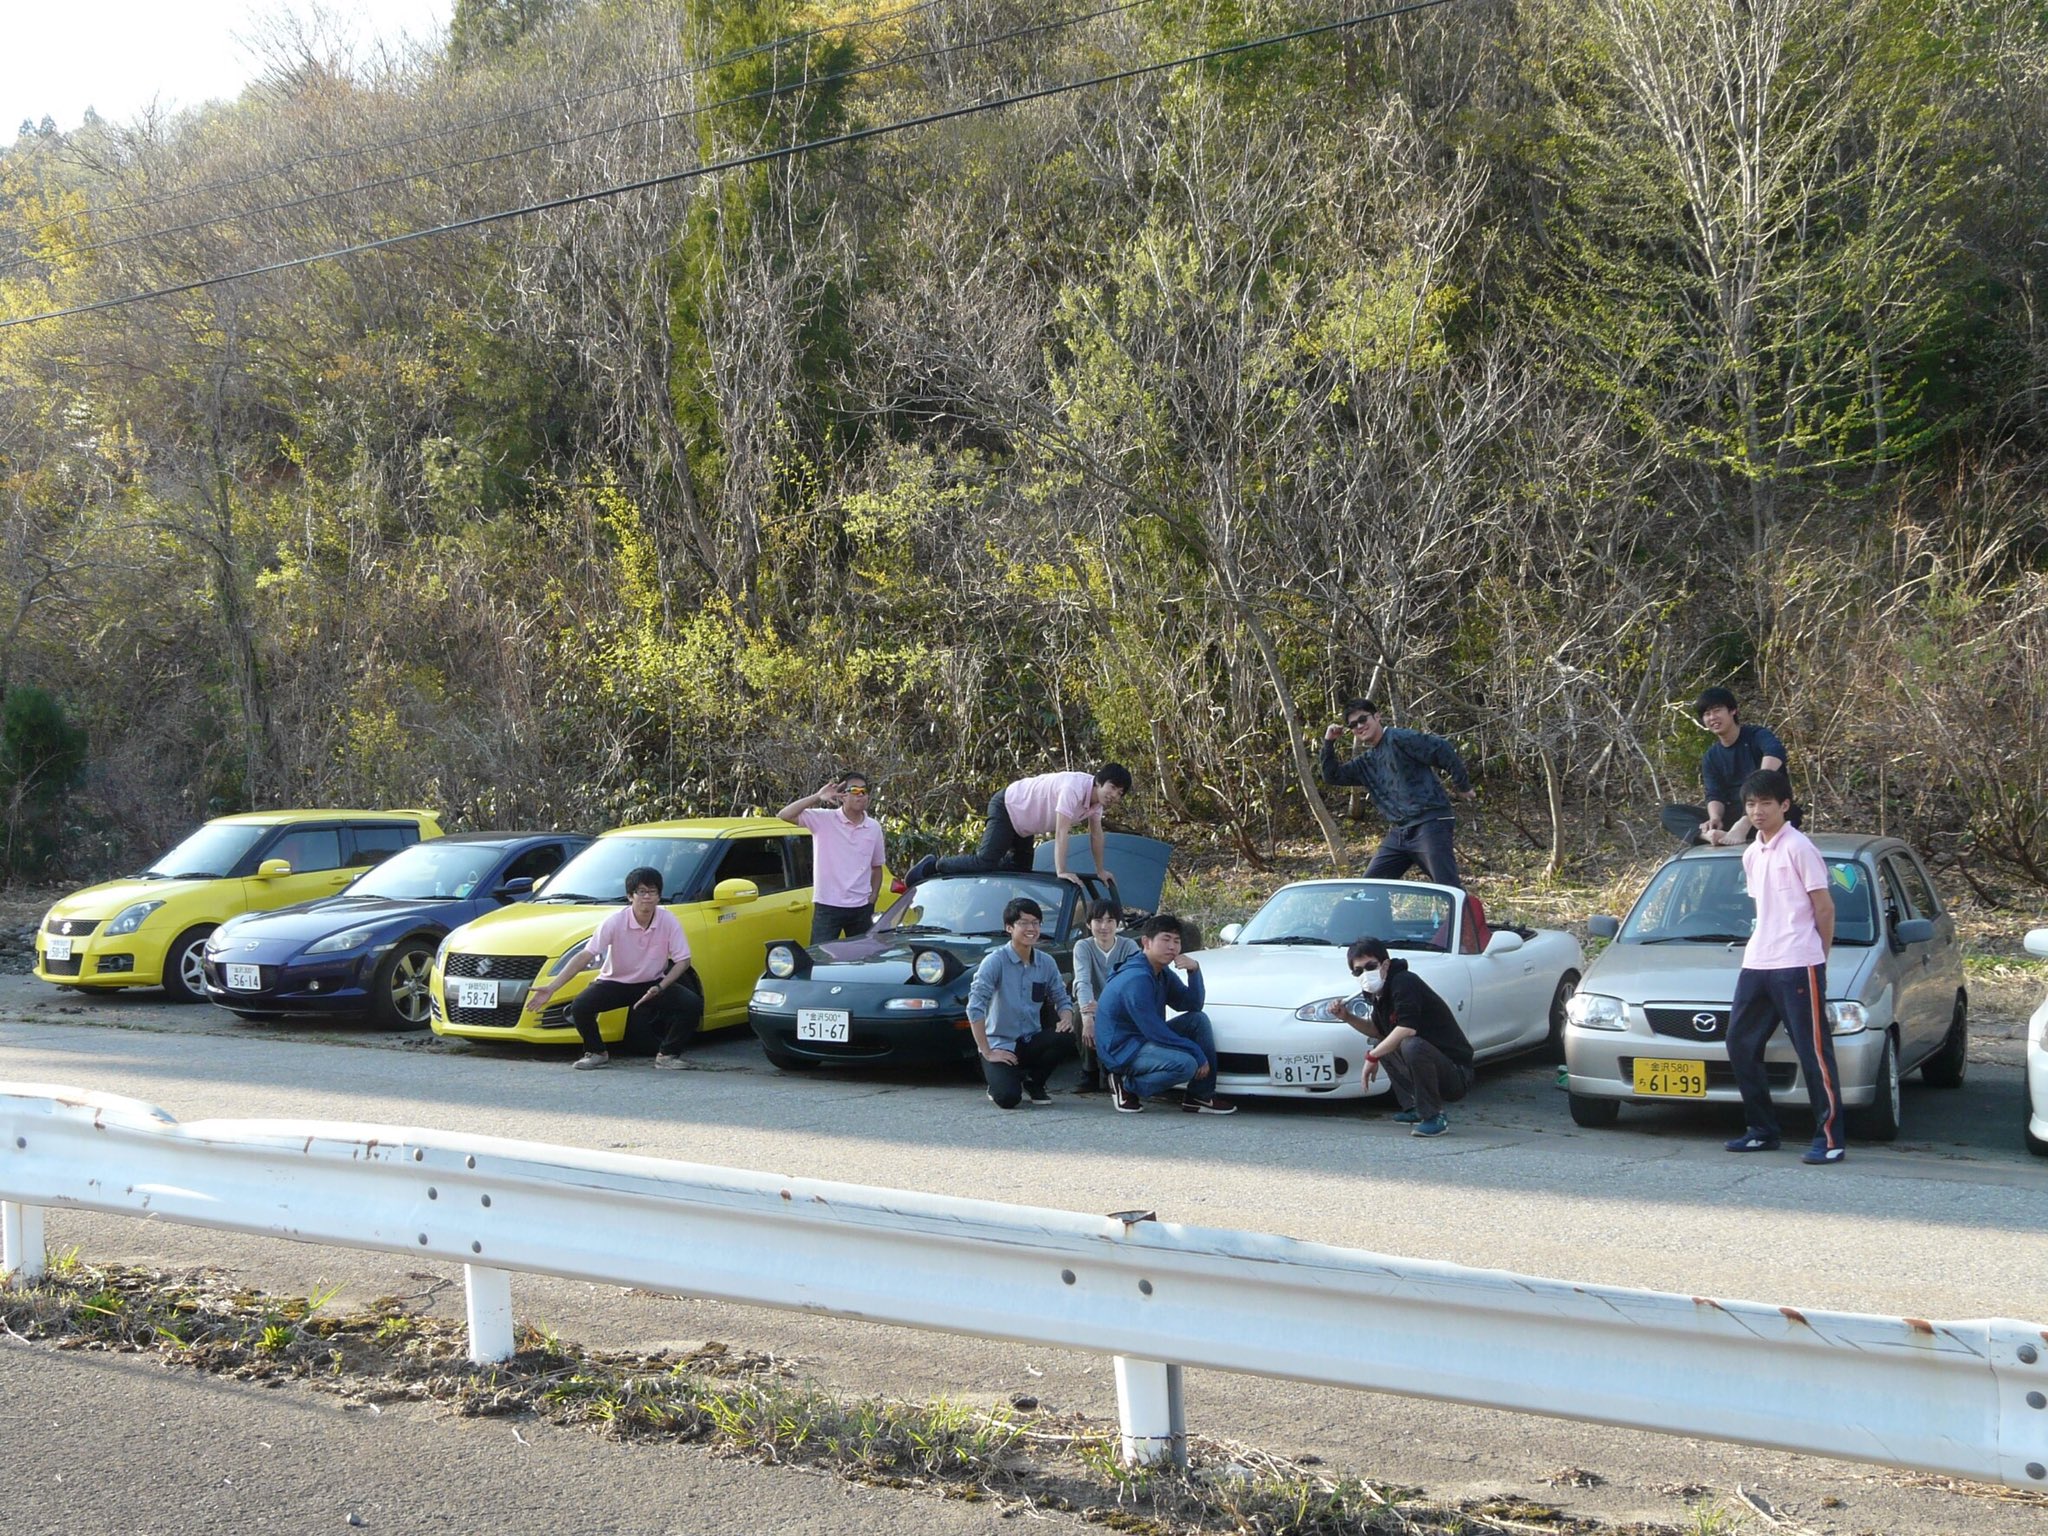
[1729,768,1843,1163]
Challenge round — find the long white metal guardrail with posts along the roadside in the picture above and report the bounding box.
[0,1083,2048,1489]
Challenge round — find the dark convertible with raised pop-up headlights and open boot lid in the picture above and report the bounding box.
[748,831,1171,1071]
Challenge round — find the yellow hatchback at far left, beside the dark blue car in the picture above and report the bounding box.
[35,811,440,1004]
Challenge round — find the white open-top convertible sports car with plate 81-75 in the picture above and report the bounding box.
[1196,881,1583,1098]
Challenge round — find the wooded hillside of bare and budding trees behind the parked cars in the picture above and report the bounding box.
[0,0,2048,885]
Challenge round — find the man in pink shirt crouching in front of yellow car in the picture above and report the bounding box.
[526,866,705,1071]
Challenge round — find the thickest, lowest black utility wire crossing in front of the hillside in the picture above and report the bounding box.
[0,0,1456,330]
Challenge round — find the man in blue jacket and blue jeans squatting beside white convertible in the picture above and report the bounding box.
[1096,913,1237,1114]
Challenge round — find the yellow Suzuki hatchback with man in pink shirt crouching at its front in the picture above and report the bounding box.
[432,815,811,1044]
